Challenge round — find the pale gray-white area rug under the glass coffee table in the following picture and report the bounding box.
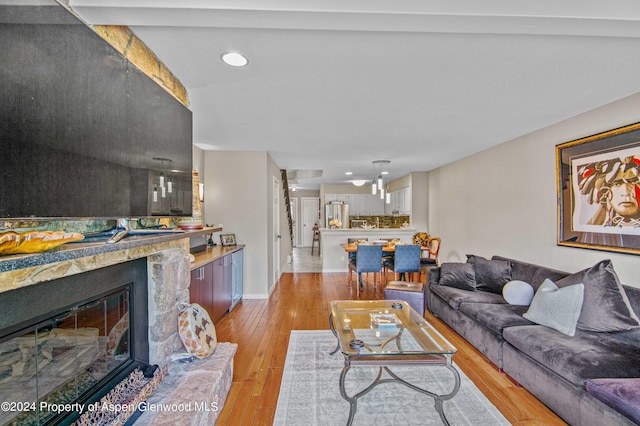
[273,330,510,426]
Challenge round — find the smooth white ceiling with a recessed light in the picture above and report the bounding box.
[69,0,640,188]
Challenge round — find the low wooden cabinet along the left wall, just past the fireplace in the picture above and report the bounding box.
[189,248,243,323]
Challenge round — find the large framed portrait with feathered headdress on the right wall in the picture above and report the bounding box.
[556,123,640,254]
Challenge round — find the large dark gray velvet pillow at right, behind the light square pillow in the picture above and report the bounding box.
[558,259,640,332]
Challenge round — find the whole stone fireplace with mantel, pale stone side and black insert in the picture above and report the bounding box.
[0,235,190,424]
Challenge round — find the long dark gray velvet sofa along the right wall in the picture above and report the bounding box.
[426,256,640,426]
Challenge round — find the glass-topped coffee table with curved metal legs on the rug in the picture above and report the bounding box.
[329,300,460,425]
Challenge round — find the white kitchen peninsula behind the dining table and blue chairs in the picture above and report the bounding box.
[320,228,417,272]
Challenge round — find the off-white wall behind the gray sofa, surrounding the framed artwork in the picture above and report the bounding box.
[428,94,640,287]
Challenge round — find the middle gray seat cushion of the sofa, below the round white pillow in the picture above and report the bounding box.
[460,302,533,336]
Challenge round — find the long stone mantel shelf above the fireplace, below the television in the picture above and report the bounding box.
[0,228,222,272]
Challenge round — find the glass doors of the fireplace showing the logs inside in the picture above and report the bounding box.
[0,286,131,425]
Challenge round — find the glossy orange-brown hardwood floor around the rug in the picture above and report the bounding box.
[216,273,566,425]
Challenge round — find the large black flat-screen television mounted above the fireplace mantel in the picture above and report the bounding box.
[0,2,192,218]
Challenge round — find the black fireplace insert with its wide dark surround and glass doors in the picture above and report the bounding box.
[0,258,149,425]
